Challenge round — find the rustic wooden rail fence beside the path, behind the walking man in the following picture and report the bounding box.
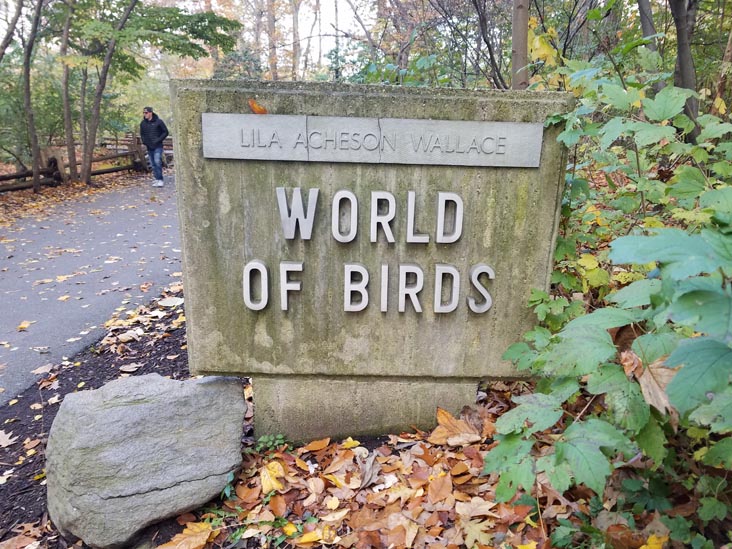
[0,133,173,193]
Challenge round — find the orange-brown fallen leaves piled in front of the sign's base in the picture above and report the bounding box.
[163,408,546,549]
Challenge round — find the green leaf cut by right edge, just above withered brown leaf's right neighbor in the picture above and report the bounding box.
[669,291,732,342]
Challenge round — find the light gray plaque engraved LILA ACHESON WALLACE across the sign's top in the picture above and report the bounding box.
[202,113,543,168]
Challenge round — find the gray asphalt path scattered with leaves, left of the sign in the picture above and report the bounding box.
[0,176,182,404]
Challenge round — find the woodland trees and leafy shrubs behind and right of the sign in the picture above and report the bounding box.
[0,0,732,547]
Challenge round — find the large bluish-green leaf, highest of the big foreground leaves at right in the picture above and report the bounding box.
[610,229,721,280]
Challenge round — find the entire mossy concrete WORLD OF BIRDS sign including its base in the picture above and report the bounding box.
[173,81,572,439]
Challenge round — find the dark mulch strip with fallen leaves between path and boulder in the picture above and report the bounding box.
[0,282,197,547]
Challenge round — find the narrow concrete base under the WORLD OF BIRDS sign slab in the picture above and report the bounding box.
[252,376,478,441]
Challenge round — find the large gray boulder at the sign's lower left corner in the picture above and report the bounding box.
[46,374,246,548]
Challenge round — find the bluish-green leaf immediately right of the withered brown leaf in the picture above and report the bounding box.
[666,337,732,414]
